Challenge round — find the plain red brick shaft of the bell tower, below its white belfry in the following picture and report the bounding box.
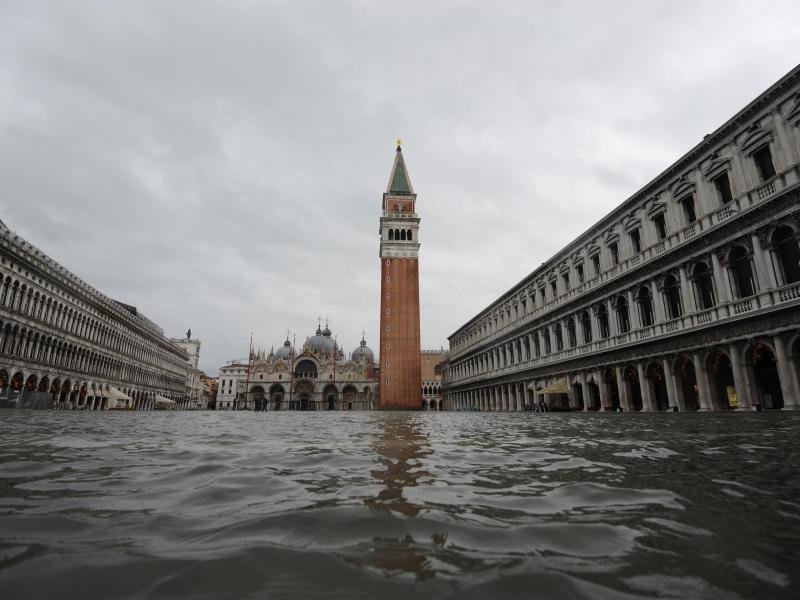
[378,258,422,410]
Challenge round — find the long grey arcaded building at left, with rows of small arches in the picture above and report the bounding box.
[0,221,189,410]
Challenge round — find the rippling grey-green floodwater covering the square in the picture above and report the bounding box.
[0,410,800,600]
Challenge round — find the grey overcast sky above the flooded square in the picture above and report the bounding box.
[0,0,800,374]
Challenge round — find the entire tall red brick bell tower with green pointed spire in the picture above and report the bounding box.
[378,140,422,410]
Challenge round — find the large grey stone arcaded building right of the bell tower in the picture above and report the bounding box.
[441,67,800,411]
